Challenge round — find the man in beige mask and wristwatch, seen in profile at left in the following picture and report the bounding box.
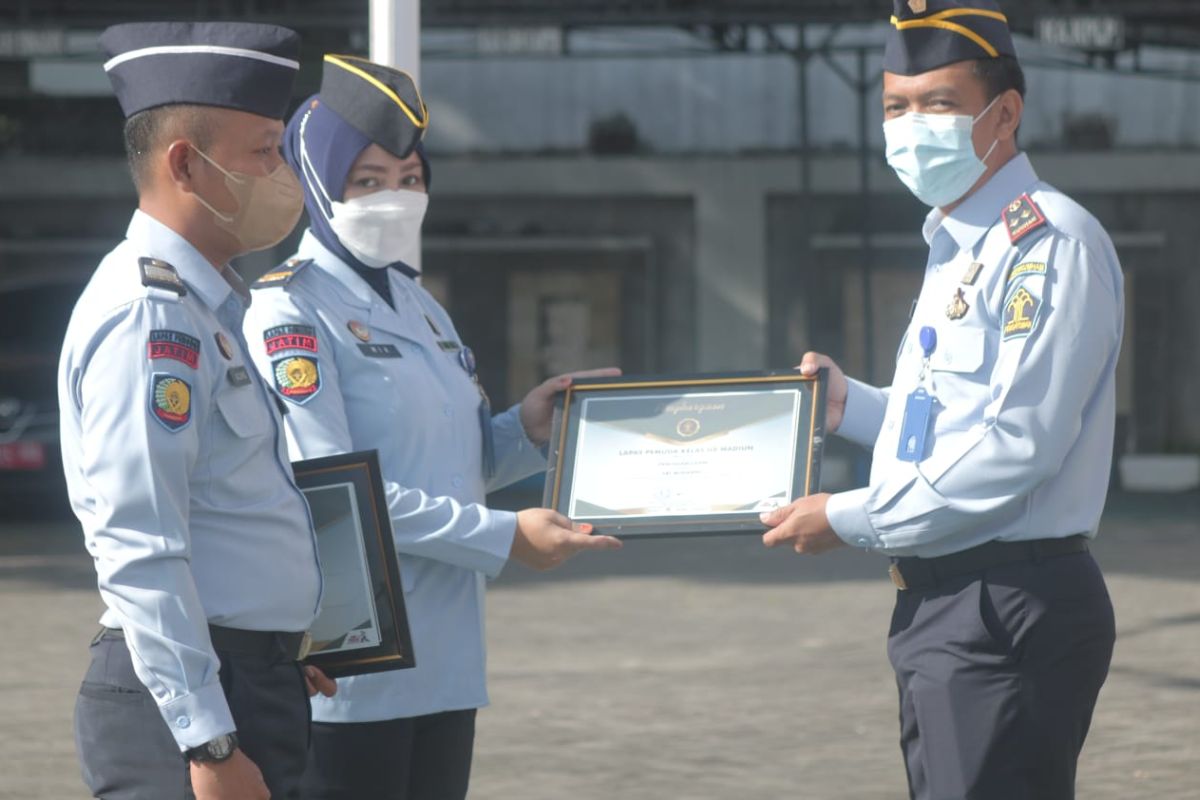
[59,23,332,800]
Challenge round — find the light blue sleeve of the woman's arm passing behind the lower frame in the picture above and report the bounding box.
[244,289,518,577]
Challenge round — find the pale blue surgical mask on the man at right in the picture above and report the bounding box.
[883,95,1000,207]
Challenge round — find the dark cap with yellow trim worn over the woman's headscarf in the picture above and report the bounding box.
[318,54,430,158]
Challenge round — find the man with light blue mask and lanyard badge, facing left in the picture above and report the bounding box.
[763,0,1124,800]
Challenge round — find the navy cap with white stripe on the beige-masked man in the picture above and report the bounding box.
[100,23,300,120]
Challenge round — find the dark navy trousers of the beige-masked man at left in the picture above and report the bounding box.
[74,637,310,800]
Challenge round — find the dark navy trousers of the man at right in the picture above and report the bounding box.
[888,553,1115,800]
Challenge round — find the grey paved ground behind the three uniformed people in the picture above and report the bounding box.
[0,495,1200,800]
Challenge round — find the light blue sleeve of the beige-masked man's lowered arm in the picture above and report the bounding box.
[64,300,235,751]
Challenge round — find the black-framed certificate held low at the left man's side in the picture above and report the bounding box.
[292,450,416,678]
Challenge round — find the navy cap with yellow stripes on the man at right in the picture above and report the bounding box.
[883,0,1016,76]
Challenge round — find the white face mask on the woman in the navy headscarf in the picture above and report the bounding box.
[329,190,430,269]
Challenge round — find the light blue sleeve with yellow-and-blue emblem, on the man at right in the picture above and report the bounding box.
[827,233,1122,551]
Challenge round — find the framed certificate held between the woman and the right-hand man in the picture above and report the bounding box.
[544,371,827,537]
